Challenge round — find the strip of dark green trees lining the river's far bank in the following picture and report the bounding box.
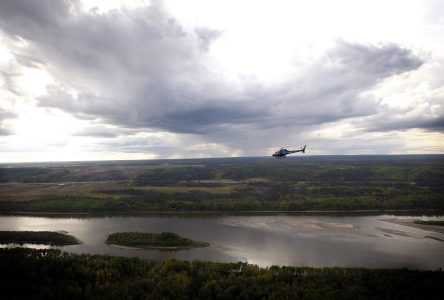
[0,193,444,213]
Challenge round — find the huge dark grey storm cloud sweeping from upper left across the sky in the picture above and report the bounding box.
[0,0,423,141]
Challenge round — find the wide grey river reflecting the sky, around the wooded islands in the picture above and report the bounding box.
[0,214,444,270]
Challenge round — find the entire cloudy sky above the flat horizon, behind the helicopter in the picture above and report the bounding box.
[0,0,444,162]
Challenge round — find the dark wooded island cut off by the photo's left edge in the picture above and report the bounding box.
[0,231,81,246]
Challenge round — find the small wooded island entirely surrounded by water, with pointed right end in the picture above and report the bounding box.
[105,232,210,250]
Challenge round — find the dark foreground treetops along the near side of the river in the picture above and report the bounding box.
[0,248,444,300]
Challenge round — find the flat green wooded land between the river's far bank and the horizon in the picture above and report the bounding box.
[0,155,444,214]
